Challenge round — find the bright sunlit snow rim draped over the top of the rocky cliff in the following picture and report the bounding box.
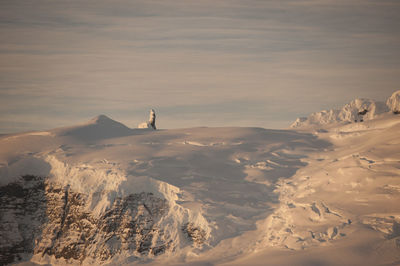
[46,156,210,260]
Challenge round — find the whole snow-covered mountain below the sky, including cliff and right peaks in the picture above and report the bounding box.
[0,92,400,265]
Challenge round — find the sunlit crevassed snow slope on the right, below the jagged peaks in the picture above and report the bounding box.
[219,114,400,265]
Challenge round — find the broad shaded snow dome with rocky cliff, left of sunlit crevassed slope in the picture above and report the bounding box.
[0,116,328,264]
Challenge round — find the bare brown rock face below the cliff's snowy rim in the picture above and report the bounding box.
[0,176,171,265]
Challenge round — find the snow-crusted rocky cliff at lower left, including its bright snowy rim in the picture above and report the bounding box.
[0,155,210,265]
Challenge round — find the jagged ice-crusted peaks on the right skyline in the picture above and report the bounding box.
[291,91,400,128]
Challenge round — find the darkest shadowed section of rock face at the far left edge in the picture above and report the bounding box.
[0,176,46,265]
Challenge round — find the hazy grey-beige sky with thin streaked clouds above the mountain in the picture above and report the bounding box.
[0,0,400,133]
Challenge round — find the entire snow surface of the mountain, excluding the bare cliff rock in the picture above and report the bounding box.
[0,113,400,265]
